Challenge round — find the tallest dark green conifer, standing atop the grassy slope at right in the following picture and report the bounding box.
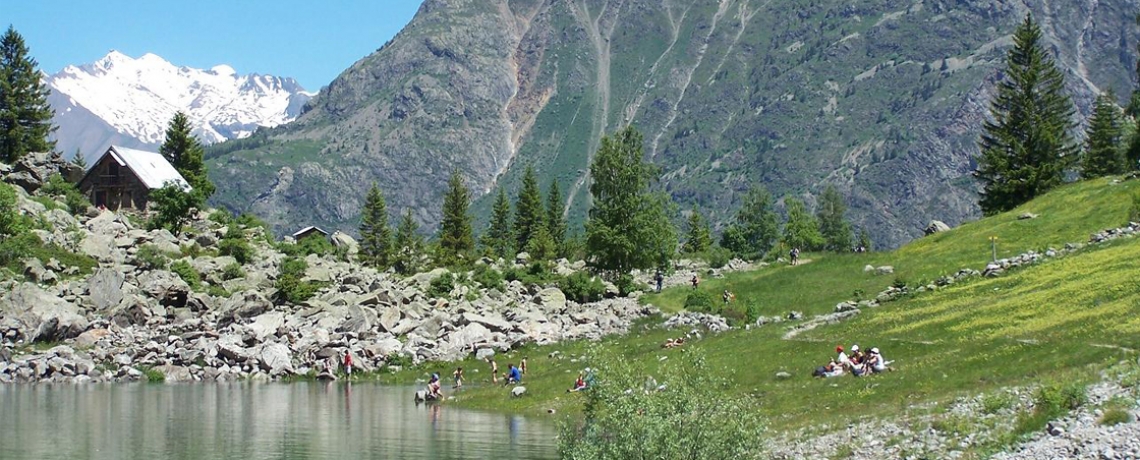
[975,16,1077,215]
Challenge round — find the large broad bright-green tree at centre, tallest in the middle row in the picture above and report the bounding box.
[586,126,677,273]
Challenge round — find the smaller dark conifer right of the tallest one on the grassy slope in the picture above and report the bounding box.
[1081,92,1124,179]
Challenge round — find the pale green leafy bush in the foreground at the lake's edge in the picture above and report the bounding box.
[559,350,763,460]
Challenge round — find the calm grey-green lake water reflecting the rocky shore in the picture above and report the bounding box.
[0,383,556,460]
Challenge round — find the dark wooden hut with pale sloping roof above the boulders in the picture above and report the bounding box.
[79,146,190,211]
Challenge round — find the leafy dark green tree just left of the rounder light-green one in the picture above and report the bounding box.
[720,184,780,258]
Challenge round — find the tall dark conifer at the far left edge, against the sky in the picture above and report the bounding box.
[0,25,56,163]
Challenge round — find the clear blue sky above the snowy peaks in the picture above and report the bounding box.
[0,0,421,91]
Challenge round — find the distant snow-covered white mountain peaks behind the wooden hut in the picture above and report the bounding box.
[46,51,312,162]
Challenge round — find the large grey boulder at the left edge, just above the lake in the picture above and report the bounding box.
[0,282,88,340]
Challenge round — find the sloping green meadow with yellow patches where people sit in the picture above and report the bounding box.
[405,176,1140,429]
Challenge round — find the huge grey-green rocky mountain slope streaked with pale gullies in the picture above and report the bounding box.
[210,0,1140,246]
